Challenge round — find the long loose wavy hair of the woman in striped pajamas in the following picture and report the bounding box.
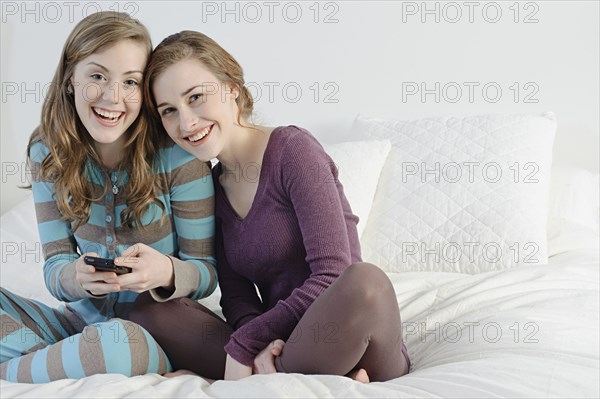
[27,12,168,231]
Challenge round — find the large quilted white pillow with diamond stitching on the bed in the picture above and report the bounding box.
[352,113,556,274]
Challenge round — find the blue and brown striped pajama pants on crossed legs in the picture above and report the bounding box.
[0,288,173,383]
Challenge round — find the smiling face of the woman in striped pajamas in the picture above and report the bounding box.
[71,40,147,156]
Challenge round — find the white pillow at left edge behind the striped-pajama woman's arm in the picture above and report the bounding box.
[0,195,60,306]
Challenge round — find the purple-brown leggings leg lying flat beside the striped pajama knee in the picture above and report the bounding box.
[129,293,233,380]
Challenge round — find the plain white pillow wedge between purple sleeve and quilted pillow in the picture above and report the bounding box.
[323,140,391,237]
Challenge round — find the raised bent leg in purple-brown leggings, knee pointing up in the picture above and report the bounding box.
[276,263,409,381]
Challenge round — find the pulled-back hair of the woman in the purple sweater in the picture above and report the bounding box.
[143,30,254,130]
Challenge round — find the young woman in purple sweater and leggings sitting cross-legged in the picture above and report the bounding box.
[130,31,410,382]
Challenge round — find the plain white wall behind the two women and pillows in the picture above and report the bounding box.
[1,1,600,213]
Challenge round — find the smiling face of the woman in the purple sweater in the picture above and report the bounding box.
[151,59,239,161]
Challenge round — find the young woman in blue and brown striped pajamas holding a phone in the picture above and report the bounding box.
[0,12,217,383]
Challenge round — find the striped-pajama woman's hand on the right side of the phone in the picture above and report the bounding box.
[115,243,175,293]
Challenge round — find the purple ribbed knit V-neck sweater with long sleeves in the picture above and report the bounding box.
[213,126,361,366]
